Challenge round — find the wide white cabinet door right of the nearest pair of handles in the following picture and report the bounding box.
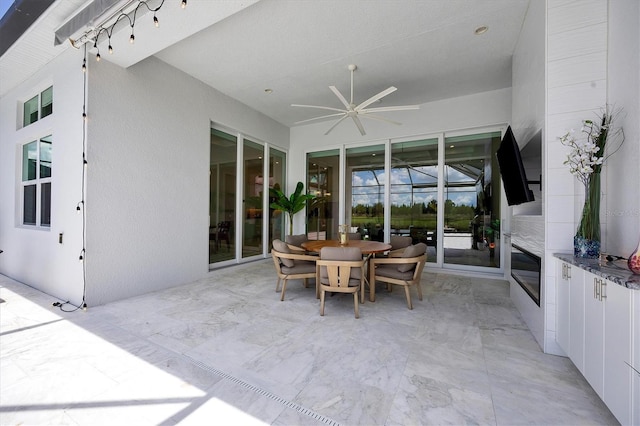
[602,281,633,425]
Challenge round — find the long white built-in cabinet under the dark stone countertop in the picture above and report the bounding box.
[556,262,640,425]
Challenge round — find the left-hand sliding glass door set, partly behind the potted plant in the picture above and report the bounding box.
[209,129,286,265]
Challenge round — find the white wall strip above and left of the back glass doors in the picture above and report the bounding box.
[288,88,511,233]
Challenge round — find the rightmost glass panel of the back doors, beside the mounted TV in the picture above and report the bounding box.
[442,132,500,268]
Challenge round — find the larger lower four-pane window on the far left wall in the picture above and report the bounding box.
[22,135,52,227]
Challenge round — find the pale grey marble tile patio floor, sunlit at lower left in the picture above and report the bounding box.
[0,259,617,426]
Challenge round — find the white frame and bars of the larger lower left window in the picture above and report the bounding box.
[18,134,53,229]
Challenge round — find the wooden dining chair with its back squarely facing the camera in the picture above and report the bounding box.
[316,247,366,318]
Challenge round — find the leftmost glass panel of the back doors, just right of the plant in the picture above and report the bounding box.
[307,149,340,240]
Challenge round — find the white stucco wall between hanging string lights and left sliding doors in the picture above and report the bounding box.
[87,58,289,304]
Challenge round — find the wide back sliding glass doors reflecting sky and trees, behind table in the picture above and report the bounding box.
[307,129,501,271]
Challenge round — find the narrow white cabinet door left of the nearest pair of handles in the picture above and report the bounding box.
[582,272,604,400]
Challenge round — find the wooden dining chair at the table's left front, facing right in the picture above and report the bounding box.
[271,239,317,301]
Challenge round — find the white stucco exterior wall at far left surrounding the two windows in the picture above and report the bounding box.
[0,48,83,304]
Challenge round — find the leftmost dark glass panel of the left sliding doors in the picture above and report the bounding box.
[209,129,237,263]
